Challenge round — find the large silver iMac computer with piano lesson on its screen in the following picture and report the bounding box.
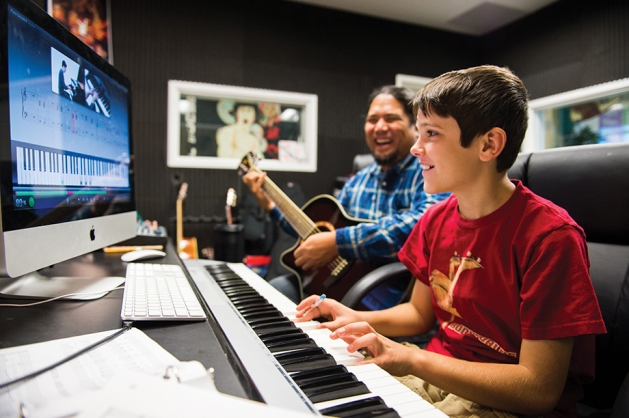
[0,0,137,297]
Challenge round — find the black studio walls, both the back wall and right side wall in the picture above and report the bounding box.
[37,0,629,251]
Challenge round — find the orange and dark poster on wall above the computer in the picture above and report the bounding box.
[48,0,114,64]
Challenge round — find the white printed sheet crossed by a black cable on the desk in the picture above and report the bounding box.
[0,328,213,418]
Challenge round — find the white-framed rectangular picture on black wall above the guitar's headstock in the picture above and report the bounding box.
[167,80,318,172]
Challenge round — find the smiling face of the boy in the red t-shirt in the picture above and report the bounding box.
[411,111,477,194]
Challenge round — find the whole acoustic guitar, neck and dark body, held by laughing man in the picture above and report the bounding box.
[238,153,381,300]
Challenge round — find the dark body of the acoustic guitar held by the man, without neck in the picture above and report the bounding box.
[281,195,380,301]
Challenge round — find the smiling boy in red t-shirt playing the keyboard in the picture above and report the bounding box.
[297,66,605,417]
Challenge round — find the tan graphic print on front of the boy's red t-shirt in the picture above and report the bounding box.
[430,251,517,357]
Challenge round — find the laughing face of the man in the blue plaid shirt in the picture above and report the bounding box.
[365,94,417,170]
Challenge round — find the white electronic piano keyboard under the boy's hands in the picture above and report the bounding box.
[184,260,445,418]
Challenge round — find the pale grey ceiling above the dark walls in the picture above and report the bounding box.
[289,0,559,36]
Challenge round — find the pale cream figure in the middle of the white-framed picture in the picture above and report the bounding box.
[216,100,267,158]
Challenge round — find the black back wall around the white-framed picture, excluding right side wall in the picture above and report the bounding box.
[105,0,479,248]
